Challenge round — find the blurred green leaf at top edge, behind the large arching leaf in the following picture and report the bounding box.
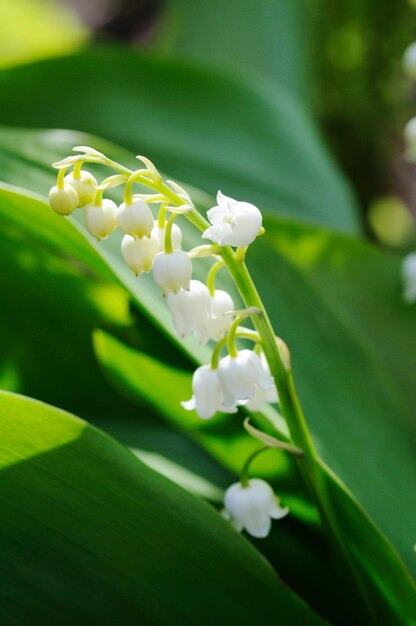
[152,0,312,99]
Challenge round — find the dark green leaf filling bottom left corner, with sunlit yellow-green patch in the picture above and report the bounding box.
[0,392,323,626]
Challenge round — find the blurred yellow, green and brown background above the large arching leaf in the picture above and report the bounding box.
[0,0,416,246]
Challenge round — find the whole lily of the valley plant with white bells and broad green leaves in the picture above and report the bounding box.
[0,3,416,626]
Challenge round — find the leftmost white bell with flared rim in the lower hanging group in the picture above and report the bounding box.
[181,365,237,419]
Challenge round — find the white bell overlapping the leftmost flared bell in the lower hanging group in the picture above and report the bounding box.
[218,350,274,406]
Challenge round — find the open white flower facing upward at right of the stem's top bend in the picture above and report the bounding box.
[202,191,263,246]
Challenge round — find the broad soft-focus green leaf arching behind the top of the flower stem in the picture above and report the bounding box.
[0,48,358,232]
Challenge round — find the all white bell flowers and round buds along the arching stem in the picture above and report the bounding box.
[49,146,287,537]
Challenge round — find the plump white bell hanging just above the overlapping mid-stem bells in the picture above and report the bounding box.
[153,250,192,296]
